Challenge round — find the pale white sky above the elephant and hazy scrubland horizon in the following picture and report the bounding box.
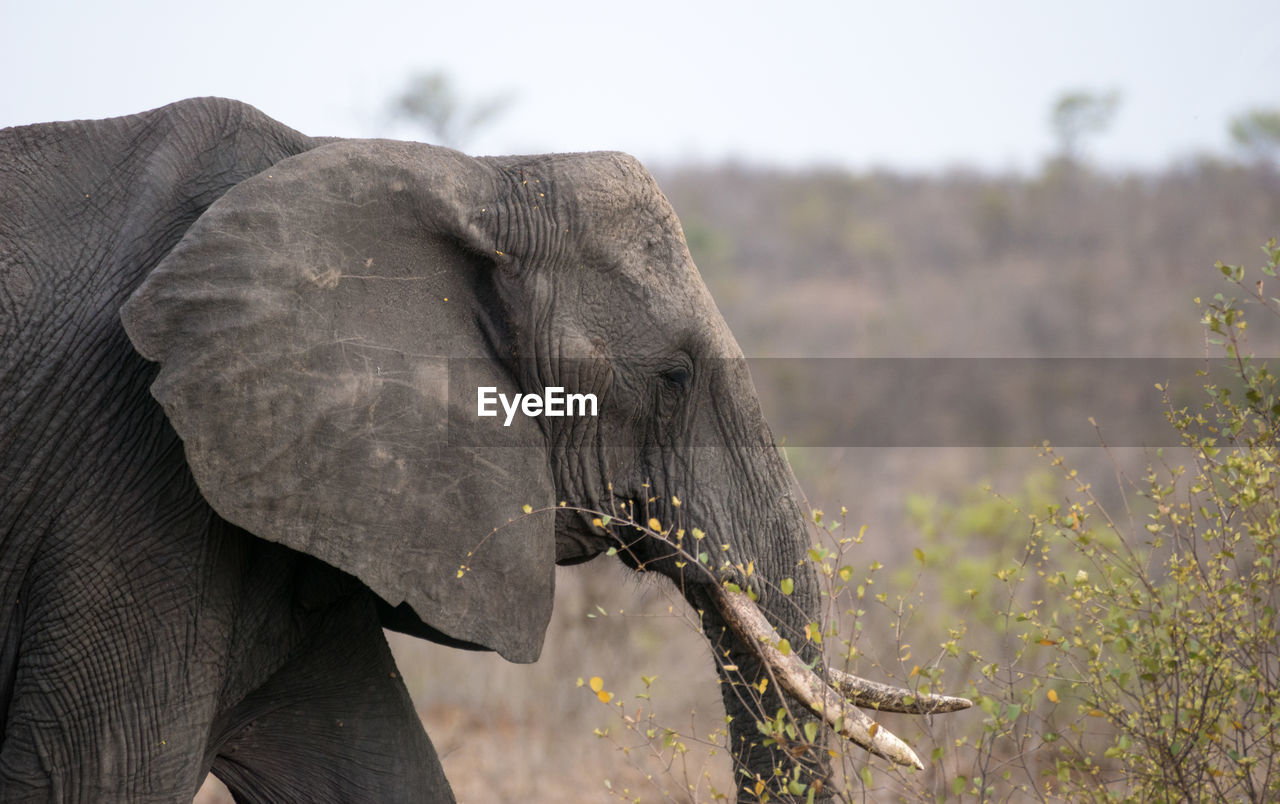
[0,0,1280,170]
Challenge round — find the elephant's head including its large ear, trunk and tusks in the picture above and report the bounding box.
[122,141,961,798]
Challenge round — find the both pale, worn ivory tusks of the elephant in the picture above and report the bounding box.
[710,584,973,769]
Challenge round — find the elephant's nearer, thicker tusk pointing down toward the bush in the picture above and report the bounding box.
[713,584,942,771]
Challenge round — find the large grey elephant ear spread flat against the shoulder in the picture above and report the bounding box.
[122,141,556,662]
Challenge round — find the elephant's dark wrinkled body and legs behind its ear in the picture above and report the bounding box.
[0,100,447,801]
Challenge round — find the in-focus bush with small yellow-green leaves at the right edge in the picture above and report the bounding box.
[1037,234,1280,801]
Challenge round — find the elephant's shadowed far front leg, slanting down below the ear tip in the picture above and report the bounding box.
[212,590,454,804]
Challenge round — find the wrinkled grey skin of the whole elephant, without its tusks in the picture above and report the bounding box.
[0,99,822,801]
